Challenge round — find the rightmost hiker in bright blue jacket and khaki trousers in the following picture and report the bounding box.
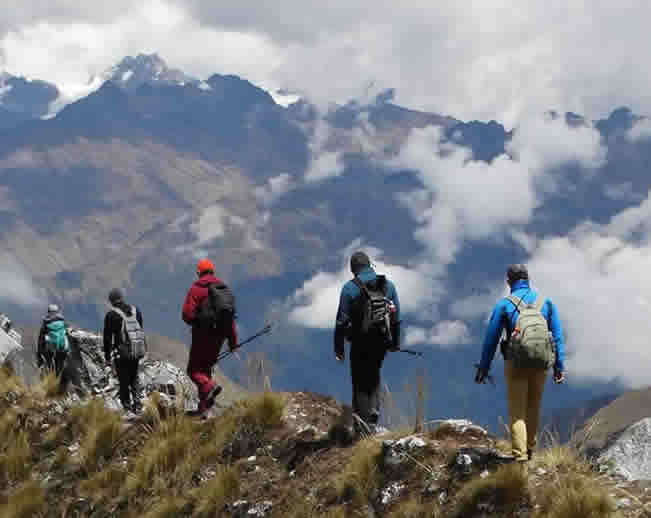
[475,264,565,470]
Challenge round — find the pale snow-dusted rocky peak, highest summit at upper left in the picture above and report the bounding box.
[103,54,199,90]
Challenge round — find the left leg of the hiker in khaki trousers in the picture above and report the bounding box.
[504,360,529,461]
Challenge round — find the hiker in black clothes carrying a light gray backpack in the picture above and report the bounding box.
[104,289,142,412]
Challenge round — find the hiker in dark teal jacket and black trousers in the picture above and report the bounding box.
[334,252,400,433]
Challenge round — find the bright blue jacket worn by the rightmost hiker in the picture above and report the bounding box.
[480,280,565,371]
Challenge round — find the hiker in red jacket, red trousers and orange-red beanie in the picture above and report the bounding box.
[182,259,237,414]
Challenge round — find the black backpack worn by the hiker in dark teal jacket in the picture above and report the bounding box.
[353,275,392,344]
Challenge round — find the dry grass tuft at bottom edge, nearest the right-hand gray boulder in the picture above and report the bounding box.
[534,473,617,518]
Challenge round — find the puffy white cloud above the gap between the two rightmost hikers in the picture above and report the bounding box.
[392,117,605,268]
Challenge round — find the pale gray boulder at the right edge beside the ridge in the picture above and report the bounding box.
[597,418,651,481]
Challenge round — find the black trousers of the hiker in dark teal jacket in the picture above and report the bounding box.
[350,346,387,427]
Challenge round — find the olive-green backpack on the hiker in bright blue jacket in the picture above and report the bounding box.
[505,295,556,369]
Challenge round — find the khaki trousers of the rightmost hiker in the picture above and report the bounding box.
[504,360,547,460]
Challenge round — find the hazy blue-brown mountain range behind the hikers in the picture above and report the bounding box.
[0,55,651,426]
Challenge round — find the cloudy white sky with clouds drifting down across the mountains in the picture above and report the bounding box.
[0,0,651,386]
